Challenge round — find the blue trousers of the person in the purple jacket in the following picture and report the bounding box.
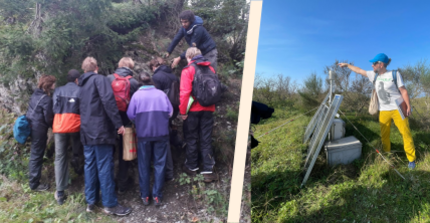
[137,139,169,198]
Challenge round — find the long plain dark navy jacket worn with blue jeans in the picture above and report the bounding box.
[78,72,123,145]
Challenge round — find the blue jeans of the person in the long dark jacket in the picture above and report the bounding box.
[84,145,118,207]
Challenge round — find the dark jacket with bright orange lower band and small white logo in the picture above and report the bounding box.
[52,82,81,133]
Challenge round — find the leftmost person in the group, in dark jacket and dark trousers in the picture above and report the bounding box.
[26,75,56,191]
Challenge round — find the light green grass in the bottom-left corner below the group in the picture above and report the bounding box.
[0,162,115,222]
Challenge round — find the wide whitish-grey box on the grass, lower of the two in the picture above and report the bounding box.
[324,136,362,166]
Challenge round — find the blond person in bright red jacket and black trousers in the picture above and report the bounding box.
[179,47,217,182]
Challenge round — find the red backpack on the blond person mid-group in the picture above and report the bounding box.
[111,74,133,112]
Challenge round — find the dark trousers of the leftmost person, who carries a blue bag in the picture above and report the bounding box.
[28,126,48,190]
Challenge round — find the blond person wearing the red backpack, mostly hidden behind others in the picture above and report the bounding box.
[107,57,139,194]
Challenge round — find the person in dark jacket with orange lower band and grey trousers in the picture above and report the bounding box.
[52,69,83,205]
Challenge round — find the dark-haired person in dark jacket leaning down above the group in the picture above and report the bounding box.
[166,10,218,71]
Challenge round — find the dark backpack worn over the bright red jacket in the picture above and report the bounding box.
[191,62,222,107]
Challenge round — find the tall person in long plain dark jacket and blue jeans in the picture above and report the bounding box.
[78,57,131,216]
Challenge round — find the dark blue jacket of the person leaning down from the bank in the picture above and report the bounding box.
[167,16,216,59]
